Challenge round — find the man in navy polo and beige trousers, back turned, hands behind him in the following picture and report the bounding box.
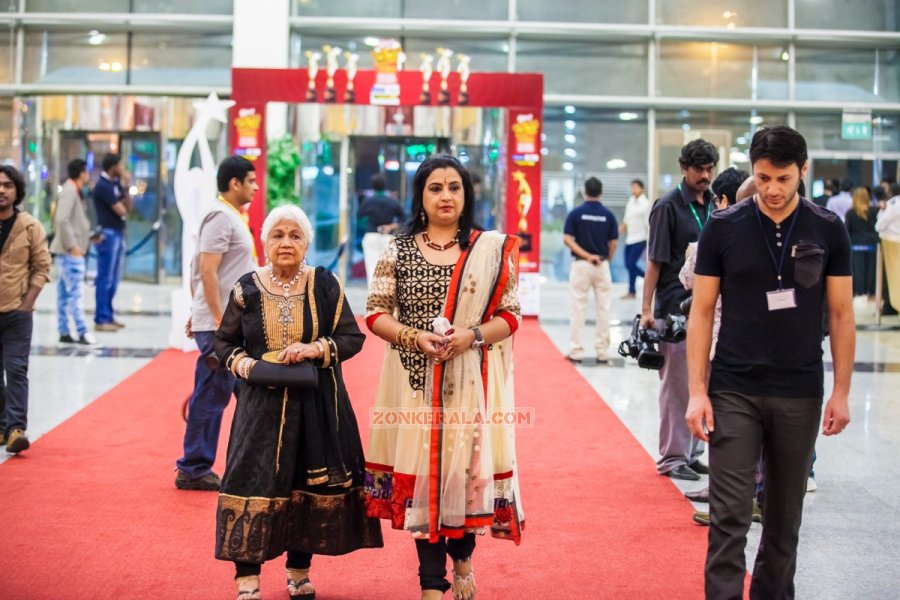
[563,177,619,364]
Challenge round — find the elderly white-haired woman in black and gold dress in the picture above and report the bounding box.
[215,206,383,600]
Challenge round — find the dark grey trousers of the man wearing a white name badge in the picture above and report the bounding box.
[706,392,822,600]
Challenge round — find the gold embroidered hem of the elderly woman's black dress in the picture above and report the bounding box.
[216,487,384,564]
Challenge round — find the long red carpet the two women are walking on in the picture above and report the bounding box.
[0,321,706,600]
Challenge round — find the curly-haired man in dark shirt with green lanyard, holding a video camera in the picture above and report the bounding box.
[641,140,719,481]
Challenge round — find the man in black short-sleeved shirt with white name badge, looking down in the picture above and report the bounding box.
[686,127,855,598]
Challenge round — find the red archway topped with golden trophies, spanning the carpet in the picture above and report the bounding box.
[231,69,544,284]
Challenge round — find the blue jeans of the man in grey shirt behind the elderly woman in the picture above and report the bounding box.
[176,331,235,479]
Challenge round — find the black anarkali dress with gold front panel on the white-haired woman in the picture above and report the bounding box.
[215,267,383,564]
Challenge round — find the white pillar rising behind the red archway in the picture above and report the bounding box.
[231,0,291,139]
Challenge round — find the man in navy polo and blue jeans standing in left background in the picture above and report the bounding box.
[93,154,131,331]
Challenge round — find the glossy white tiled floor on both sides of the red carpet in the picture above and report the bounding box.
[8,282,900,599]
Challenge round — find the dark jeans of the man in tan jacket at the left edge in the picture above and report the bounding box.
[0,310,34,434]
